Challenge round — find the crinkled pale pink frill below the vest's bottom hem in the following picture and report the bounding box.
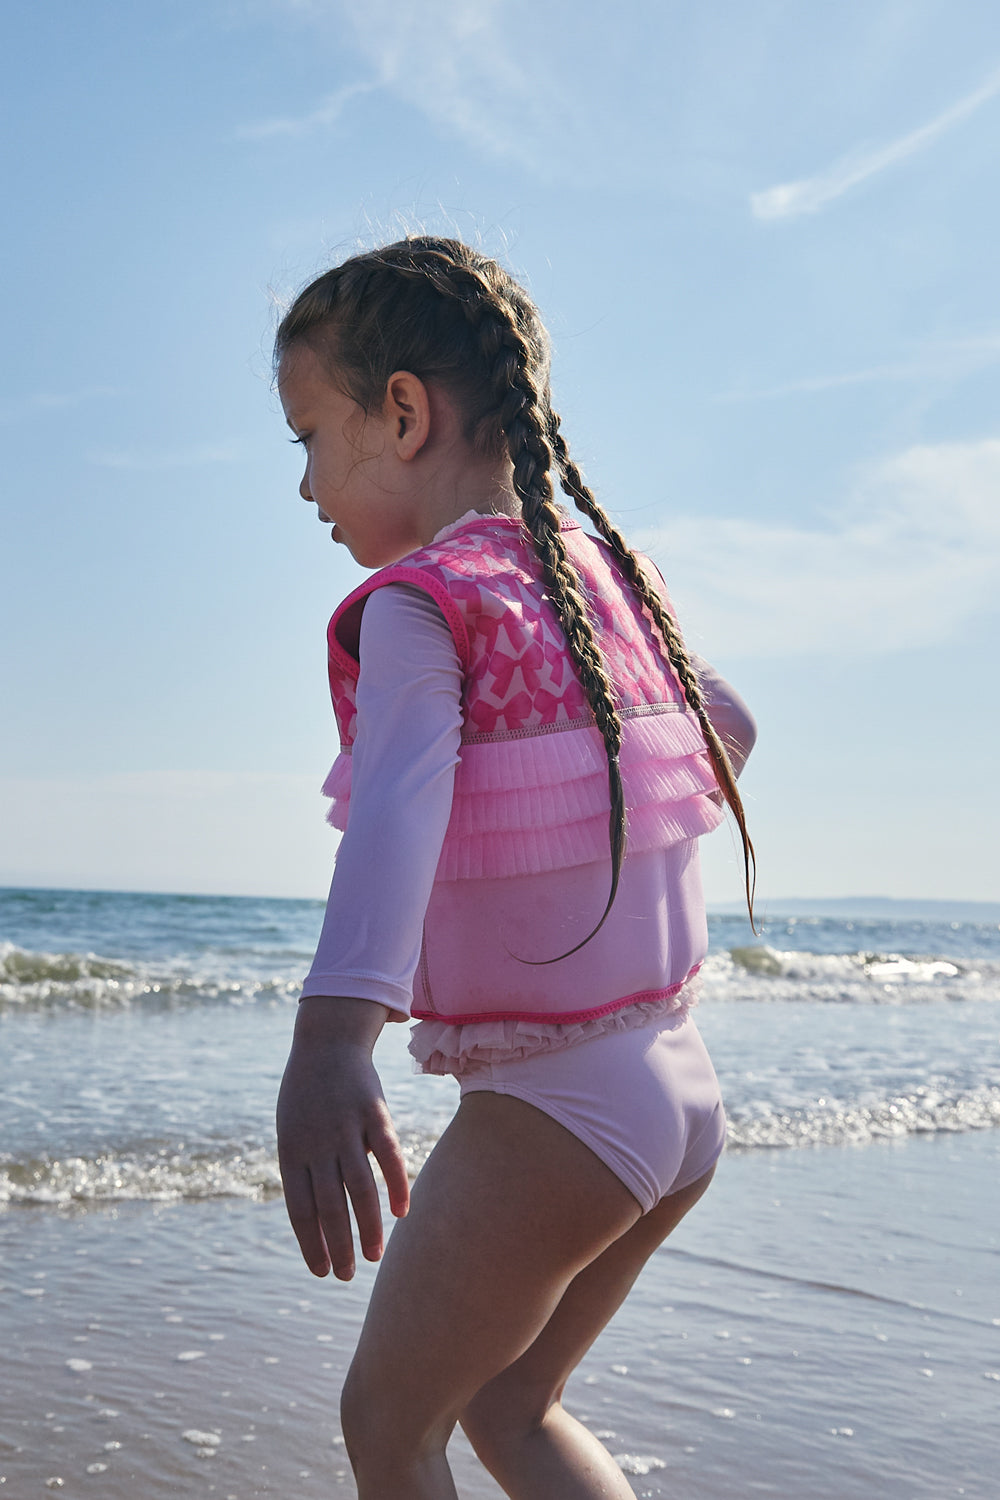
[409,978,697,1077]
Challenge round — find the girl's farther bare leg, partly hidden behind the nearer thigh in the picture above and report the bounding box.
[460,1169,715,1500]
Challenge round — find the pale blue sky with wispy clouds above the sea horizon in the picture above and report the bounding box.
[0,0,1000,902]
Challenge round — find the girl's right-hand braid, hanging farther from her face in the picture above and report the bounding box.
[549,411,757,933]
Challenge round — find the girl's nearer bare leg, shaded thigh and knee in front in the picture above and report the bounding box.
[342,1094,640,1500]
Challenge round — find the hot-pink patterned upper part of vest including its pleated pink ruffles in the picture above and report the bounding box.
[324,516,723,1019]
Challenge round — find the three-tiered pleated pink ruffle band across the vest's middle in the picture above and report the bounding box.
[324,705,723,881]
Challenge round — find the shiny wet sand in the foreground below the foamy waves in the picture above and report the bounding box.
[0,1131,1000,1500]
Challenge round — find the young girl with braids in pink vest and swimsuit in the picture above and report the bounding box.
[276,237,754,1500]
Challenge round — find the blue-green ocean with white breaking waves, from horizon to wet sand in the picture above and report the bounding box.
[0,890,1000,1208]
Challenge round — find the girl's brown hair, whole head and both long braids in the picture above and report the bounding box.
[274,236,756,963]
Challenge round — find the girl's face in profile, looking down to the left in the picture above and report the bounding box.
[277,345,423,567]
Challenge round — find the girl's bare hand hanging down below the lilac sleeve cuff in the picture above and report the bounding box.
[277,996,409,1281]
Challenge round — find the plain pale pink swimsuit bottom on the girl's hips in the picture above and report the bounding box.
[459,1016,726,1214]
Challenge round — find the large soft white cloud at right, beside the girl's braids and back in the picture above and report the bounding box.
[643,440,1000,657]
